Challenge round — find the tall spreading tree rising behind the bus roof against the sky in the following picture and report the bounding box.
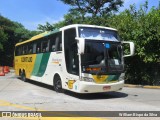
[37,0,123,31]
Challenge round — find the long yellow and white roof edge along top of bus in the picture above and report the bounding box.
[16,24,117,46]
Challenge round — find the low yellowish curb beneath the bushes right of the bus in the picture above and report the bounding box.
[124,84,160,89]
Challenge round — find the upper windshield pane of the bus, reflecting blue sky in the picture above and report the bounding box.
[79,27,119,41]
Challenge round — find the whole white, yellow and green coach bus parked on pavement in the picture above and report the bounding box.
[14,24,134,93]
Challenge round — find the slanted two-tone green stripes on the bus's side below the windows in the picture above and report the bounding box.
[32,53,50,77]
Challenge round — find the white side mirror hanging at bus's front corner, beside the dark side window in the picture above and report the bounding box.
[75,37,85,54]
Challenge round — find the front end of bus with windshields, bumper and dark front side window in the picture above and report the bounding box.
[64,27,124,93]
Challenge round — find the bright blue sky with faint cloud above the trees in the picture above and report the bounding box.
[0,0,159,30]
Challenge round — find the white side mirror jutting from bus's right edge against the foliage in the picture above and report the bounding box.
[122,41,135,57]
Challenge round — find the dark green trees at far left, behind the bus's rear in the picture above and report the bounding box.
[0,16,37,66]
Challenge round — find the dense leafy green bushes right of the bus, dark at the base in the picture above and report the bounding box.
[107,2,160,85]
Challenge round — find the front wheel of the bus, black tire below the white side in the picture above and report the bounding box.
[53,75,62,93]
